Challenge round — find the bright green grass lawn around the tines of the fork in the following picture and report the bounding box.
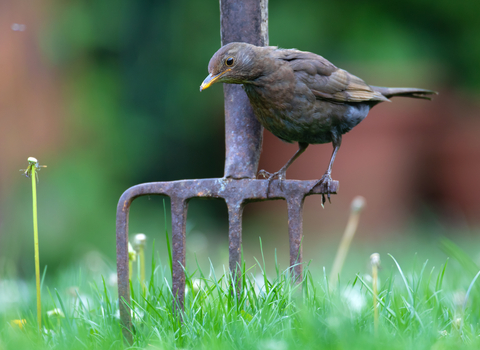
[0,241,480,350]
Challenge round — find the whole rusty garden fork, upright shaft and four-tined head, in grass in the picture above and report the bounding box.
[116,0,338,340]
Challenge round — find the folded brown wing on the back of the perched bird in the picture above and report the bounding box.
[277,50,388,102]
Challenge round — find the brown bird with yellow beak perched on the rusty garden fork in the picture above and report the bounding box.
[200,42,436,203]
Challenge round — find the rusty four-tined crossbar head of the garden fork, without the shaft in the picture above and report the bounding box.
[117,178,338,334]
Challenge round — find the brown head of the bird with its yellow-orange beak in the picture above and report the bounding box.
[200,42,262,91]
